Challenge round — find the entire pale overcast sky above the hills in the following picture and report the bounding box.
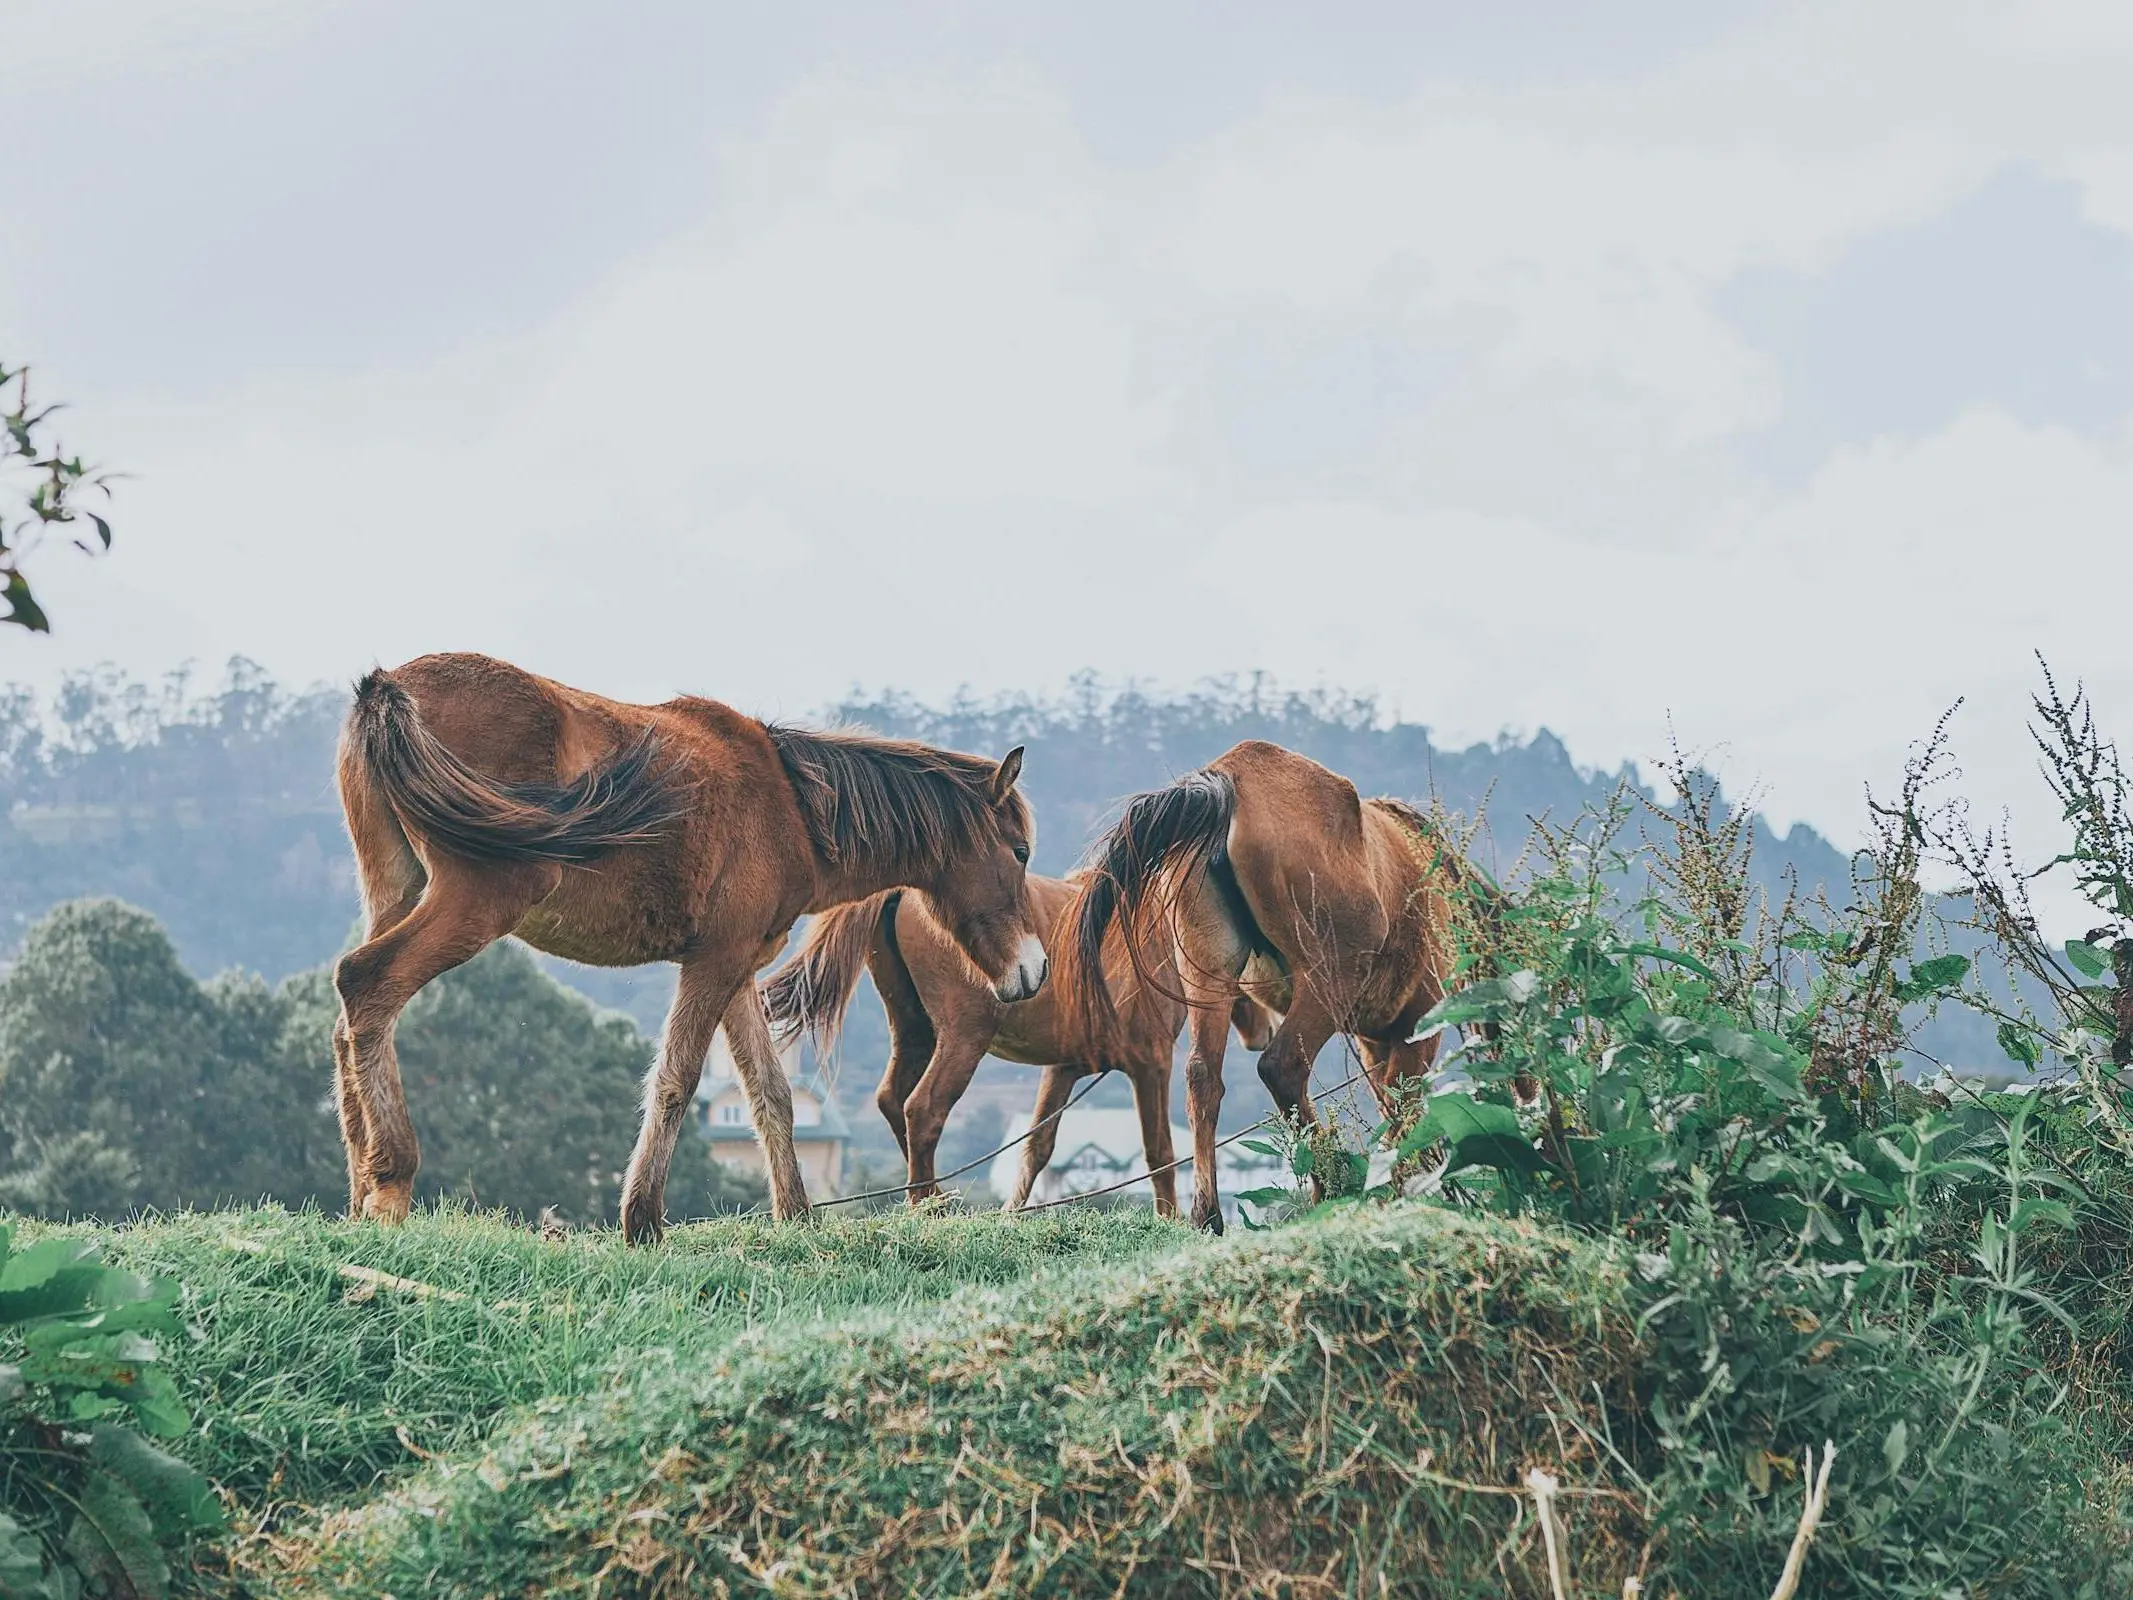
[0,0,2133,891]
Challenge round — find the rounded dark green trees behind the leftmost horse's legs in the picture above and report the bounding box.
[0,900,764,1222]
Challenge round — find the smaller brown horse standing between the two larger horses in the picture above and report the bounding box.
[764,873,1271,1216]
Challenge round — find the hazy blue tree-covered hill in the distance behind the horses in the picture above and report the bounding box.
[0,659,1996,1154]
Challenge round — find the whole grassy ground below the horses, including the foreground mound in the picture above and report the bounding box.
[12,1203,2124,1600]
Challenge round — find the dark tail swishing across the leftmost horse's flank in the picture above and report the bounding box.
[341,672,685,862]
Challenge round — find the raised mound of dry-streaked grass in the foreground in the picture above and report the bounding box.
[243,1207,1647,1596]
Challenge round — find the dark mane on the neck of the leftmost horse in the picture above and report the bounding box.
[764,723,1030,877]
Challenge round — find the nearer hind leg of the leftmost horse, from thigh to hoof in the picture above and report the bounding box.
[333,866,559,1222]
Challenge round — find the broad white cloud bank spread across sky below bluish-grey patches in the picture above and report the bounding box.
[12,4,2133,925]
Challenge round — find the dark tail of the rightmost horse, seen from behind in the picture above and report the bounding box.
[1075,768,1237,1035]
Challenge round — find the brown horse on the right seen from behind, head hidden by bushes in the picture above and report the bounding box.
[1075,740,1461,1233]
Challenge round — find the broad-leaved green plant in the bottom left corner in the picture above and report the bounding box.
[0,1225,222,1600]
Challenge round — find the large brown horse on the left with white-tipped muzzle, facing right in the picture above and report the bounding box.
[333,655,1047,1242]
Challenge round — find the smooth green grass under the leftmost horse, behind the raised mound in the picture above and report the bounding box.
[87,1207,1180,1515]
